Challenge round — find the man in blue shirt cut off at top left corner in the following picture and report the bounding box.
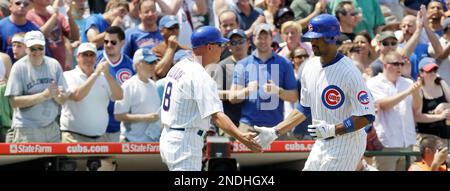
[0,0,46,63]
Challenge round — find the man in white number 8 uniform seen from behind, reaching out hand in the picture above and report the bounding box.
[160,26,261,171]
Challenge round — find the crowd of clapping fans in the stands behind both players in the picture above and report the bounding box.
[0,0,450,170]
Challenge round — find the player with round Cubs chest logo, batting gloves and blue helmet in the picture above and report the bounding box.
[255,14,375,171]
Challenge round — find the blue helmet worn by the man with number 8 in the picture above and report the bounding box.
[191,26,228,48]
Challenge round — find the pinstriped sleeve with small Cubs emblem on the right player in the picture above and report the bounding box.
[347,70,375,116]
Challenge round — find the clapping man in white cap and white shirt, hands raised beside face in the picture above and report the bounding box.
[60,43,123,143]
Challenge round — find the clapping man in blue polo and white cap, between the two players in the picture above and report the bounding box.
[230,24,298,137]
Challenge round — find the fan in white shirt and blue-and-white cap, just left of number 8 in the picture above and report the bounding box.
[114,48,161,142]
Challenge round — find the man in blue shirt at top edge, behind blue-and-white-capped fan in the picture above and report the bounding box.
[123,1,164,58]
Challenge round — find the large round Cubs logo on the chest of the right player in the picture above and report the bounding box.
[322,85,345,109]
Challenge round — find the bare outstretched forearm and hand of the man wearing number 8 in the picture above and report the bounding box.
[211,112,262,152]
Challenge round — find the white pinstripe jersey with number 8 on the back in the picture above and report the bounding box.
[161,58,223,130]
